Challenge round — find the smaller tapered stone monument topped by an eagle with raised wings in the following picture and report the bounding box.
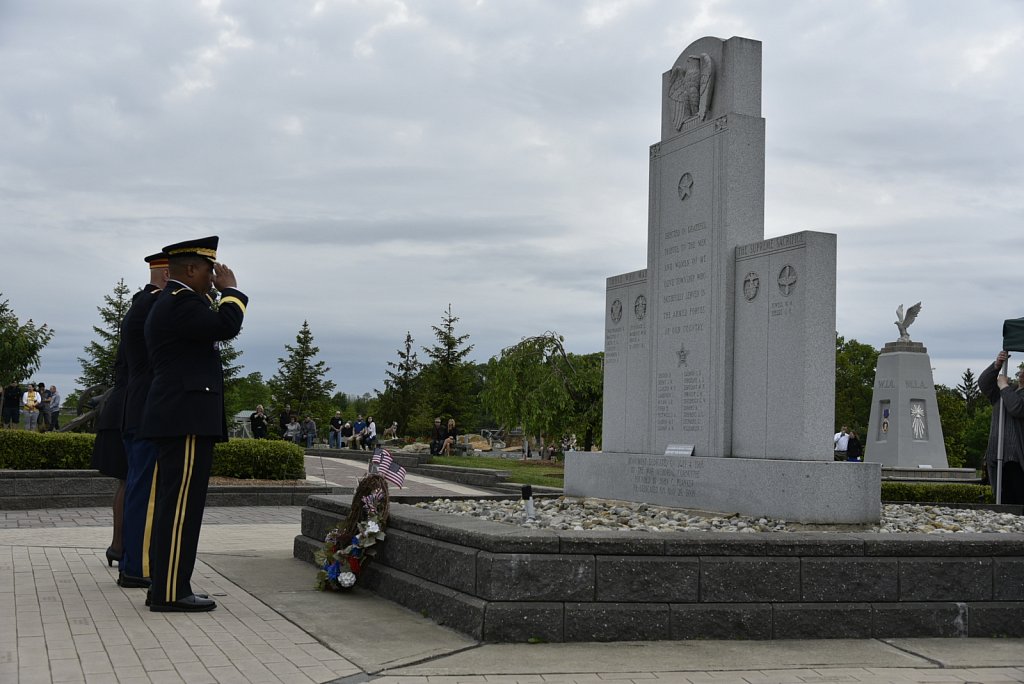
[864,302,949,468]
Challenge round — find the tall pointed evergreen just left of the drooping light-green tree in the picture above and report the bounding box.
[413,304,474,430]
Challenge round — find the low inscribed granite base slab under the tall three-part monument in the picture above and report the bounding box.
[564,452,882,524]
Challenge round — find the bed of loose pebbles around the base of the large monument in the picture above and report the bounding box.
[417,497,1024,535]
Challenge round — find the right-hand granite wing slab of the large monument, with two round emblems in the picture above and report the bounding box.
[732,231,836,461]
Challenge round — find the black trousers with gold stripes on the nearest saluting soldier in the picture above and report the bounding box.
[150,435,214,603]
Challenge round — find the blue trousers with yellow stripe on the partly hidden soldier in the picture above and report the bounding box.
[120,434,157,578]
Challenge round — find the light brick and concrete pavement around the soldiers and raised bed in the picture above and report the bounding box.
[0,459,1024,684]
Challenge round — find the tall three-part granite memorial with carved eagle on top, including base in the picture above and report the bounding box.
[565,38,881,522]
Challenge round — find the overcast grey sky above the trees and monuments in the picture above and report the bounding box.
[0,0,1024,403]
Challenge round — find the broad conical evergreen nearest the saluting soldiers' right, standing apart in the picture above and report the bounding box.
[269,320,334,422]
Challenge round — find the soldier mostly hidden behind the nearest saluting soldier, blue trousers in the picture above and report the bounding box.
[118,252,169,588]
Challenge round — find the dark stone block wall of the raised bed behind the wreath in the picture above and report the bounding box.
[295,497,1024,642]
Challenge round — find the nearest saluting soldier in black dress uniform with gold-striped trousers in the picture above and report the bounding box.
[137,236,249,612]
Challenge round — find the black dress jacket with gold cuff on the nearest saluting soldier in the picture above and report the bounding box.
[138,281,249,441]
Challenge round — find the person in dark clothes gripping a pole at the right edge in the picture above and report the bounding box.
[978,351,1024,504]
